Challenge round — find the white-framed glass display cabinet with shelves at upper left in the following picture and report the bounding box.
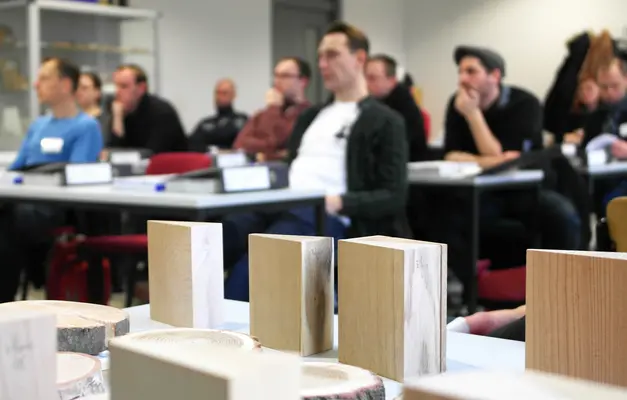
[0,0,159,150]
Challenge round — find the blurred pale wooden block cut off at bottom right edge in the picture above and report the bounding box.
[403,371,627,400]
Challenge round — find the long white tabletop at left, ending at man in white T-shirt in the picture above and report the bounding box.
[0,184,324,210]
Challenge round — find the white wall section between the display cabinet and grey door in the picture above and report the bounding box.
[132,0,272,131]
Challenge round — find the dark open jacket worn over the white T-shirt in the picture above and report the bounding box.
[288,97,411,237]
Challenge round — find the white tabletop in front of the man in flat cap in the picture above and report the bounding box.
[408,170,544,187]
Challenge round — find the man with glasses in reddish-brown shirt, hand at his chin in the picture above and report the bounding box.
[233,57,311,161]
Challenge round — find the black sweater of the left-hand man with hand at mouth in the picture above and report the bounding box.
[109,94,187,154]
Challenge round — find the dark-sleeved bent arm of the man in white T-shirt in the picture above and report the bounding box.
[339,115,409,218]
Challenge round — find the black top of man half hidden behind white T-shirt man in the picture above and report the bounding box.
[380,84,427,161]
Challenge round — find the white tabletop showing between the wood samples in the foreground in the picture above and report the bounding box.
[125,300,525,399]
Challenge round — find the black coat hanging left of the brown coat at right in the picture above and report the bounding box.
[544,32,590,135]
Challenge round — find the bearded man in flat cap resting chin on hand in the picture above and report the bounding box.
[430,47,581,304]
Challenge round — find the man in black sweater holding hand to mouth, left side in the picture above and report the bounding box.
[108,64,188,154]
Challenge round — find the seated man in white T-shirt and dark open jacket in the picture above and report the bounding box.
[223,23,408,301]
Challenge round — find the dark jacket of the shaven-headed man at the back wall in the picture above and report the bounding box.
[189,107,248,153]
